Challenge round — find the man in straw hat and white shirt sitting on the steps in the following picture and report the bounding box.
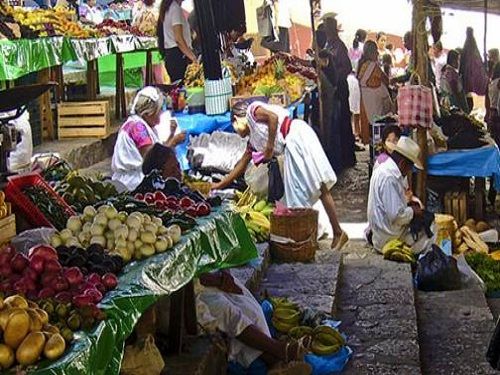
[367,137,434,253]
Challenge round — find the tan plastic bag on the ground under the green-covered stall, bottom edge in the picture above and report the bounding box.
[120,335,165,375]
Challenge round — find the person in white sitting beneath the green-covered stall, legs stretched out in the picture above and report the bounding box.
[196,271,311,375]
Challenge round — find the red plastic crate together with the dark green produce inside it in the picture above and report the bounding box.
[5,173,75,230]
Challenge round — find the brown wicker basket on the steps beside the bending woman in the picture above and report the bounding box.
[271,208,318,263]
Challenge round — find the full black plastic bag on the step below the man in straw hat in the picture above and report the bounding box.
[416,245,461,292]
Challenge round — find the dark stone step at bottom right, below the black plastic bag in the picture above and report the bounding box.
[416,289,496,375]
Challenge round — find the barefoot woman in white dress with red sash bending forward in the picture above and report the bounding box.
[213,101,348,249]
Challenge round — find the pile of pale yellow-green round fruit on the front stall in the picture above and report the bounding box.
[51,205,182,262]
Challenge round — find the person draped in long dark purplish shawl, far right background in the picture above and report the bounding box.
[460,27,489,110]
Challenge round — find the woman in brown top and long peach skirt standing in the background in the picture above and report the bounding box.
[357,40,392,144]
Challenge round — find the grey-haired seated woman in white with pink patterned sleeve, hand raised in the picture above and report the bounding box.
[111,87,185,191]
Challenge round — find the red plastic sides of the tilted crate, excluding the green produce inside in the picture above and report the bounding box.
[5,173,75,228]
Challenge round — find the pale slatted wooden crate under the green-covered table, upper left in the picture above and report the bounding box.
[57,100,110,139]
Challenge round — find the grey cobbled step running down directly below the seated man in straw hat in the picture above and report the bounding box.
[338,241,421,375]
